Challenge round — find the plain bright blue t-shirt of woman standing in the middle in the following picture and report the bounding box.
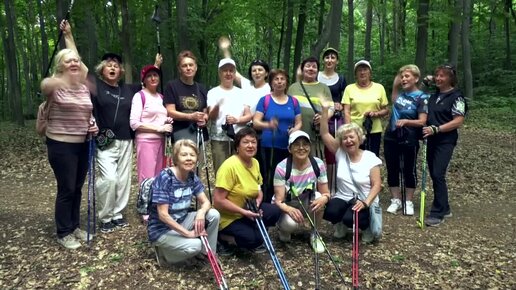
[256,96,301,149]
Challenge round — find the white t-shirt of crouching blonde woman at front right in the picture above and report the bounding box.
[335,148,382,202]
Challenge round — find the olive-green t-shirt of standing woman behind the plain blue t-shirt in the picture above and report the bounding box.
[288,82,332,140]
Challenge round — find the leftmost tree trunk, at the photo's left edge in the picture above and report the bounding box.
[2,0,24,126]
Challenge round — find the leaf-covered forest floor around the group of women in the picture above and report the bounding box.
[0,109,516,289]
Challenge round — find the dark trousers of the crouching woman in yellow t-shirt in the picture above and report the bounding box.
[219,203,281,250]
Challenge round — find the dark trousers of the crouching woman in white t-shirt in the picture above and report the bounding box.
[323,198,370,230]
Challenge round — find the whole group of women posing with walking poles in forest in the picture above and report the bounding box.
[41,21,467,264]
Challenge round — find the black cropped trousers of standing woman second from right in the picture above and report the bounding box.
[383,140,419,188]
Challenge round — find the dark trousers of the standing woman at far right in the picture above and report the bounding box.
[426,139,455,218]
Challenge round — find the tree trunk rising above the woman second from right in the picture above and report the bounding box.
[415,0,430,74]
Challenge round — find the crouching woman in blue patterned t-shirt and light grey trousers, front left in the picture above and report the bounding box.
[147,139,220,264]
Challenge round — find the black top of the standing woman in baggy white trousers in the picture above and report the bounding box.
[91,78,141,140]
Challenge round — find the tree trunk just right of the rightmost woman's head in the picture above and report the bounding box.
[462,0,473,100]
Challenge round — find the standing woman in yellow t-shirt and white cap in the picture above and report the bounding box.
[342,60,389,156]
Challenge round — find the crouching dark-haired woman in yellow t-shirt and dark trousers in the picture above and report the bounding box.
[213,127,281,256]
